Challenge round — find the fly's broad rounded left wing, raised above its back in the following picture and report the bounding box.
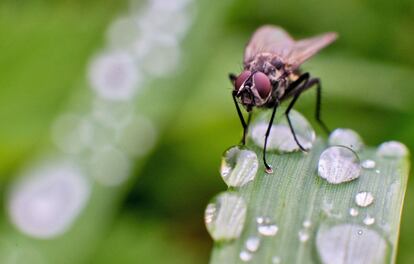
[244,25,295,64]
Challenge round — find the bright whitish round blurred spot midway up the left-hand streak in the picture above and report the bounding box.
[89,51,141,100]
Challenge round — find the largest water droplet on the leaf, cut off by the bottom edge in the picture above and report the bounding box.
[316,224,388,264]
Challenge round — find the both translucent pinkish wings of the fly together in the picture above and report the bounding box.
[244,25,337,70]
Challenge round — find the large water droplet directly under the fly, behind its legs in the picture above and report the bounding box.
[250,110,316,152]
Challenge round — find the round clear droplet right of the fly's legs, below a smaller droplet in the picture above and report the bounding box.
[318,146,361,184]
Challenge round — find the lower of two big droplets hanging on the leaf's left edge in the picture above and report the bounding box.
[204,192,247,240]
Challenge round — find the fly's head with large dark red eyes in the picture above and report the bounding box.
[234,70,272,111]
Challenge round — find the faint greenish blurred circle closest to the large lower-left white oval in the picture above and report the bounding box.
[89,145,131,186]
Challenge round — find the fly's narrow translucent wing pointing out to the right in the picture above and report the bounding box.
[283,32,337,71]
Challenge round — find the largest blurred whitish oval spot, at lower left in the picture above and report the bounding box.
[8,162,90,239]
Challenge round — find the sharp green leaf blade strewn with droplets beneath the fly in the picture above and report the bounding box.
[208,120,409,263]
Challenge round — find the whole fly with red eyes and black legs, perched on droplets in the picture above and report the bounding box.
[229,25,337,173]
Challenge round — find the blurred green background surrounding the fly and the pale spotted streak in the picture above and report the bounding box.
[0,0,414,263]
